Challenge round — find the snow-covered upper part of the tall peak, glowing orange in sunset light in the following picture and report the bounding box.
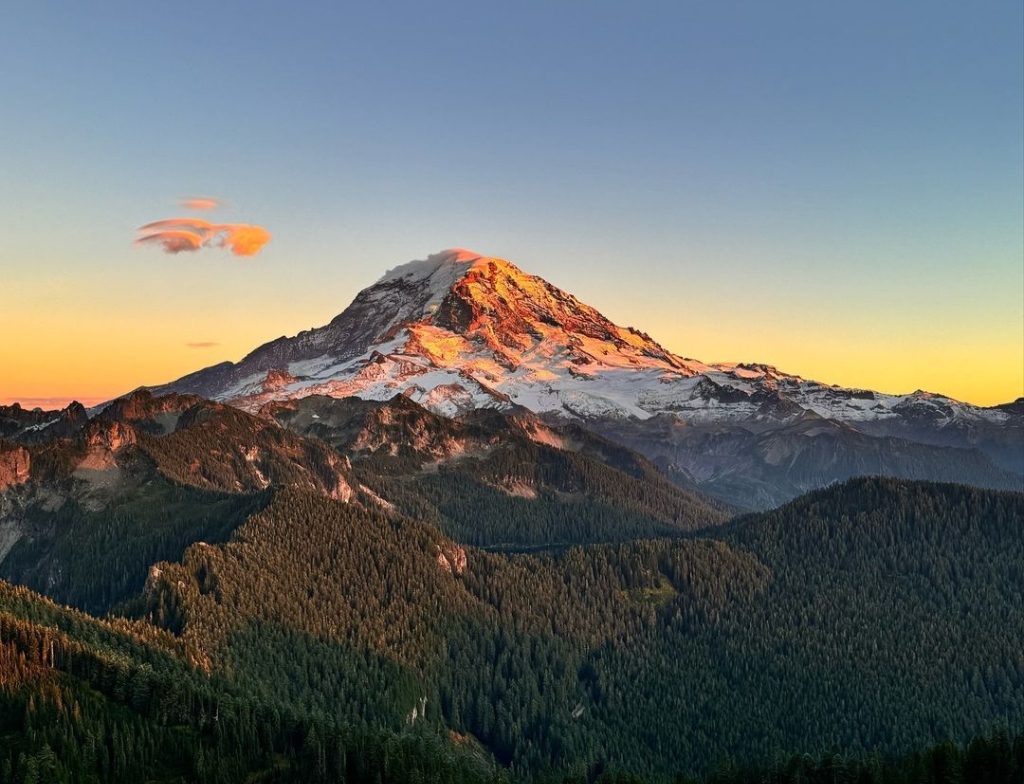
[159,249,1009,438]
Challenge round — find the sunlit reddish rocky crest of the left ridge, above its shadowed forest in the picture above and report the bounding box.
[0,390,357,507]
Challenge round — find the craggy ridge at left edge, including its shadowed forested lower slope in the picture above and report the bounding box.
[0,391,357,612]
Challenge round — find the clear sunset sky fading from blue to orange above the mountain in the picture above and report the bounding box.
[0,0,1024,407]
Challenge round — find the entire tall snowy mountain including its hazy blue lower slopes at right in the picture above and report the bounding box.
[151,250,1024,509]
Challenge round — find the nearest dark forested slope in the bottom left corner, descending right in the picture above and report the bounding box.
[0,581,499,784]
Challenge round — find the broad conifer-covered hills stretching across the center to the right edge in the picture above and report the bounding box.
[132,480,1024,774]
